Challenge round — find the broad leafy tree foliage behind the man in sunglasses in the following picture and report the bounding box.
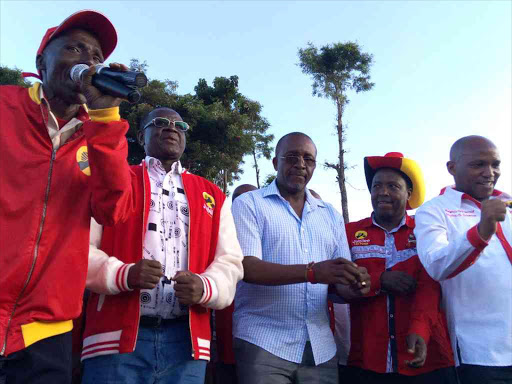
[121,59,273,192]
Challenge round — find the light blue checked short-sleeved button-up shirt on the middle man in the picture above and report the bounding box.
[232,181,350,365]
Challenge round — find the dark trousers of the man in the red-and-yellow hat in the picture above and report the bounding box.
[340,367,458,384]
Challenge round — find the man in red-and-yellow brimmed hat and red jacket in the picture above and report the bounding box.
[340,152,456,384]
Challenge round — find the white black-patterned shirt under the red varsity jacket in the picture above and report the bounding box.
[140,156,189,319]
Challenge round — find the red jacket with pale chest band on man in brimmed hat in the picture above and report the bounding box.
[346,216,454,376]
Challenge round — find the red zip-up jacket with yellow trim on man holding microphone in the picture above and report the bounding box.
[0,83,133,356]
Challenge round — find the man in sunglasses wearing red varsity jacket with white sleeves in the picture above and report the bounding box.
[82,108,243,384]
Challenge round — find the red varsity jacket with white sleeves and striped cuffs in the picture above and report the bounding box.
[82,162,243,360]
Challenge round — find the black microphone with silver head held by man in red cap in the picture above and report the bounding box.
[69,64,148,104]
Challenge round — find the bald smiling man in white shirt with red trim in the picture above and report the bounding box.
[415,136,512,384]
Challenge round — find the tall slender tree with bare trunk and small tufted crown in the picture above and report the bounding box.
[298,42,375,223]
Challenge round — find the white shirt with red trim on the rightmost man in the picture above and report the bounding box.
[414,187,512,366]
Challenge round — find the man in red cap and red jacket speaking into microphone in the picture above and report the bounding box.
[0,11,136,384]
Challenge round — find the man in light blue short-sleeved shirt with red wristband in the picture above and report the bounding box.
[232,132,370,384]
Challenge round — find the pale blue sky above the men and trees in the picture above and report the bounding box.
[0,0,512,220]
